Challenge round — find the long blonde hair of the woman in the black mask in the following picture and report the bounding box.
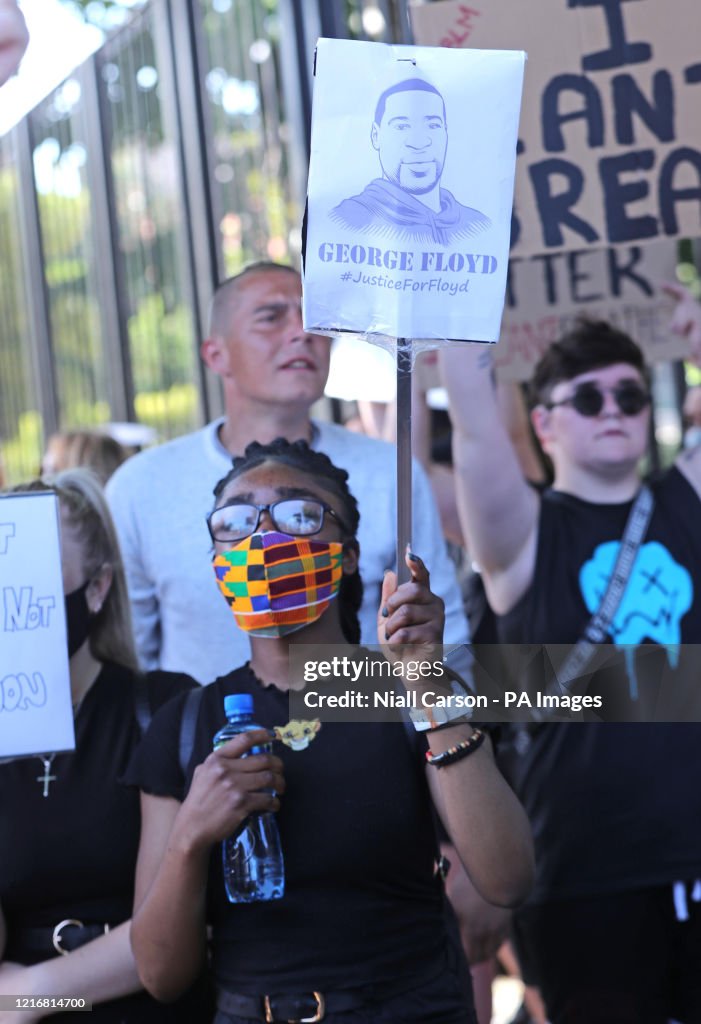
[13,468,138,671]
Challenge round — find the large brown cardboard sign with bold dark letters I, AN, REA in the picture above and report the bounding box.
[411,0,701,255]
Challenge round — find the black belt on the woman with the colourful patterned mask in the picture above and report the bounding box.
[217,961,445,1024]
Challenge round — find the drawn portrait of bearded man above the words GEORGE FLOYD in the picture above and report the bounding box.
[331,78,491,246]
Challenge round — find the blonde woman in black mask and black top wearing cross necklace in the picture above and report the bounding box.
[0,469,207,1024]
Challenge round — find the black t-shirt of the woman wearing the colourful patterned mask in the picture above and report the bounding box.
[127,667,454,993]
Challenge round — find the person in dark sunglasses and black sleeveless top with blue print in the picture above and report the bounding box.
[441,319,701,1024]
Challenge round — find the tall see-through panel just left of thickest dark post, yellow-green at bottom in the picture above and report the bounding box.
[100,11,201,438]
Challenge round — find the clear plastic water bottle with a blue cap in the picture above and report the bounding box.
[214,693,284,903]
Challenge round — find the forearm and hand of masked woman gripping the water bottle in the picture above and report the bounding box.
[131,730,284,1002]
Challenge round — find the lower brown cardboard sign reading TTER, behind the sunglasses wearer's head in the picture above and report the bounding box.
[494,242,689,381]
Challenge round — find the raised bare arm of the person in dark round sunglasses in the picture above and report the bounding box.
[440,343,538,613]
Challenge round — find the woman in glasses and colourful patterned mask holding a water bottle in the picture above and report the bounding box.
[126,438,533,1024]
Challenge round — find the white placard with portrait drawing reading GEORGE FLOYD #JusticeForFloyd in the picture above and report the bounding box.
[304,39,525,341]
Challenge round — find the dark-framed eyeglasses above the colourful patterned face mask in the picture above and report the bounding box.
[207,498,350,544]
